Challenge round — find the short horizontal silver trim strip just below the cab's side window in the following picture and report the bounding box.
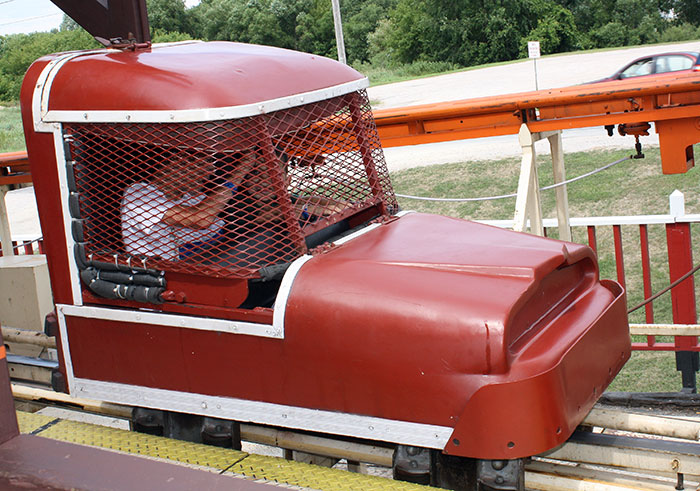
[56,305,284,339]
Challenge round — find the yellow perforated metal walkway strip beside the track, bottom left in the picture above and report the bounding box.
[17,411,436,491]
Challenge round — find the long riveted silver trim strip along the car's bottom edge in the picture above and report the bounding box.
[71,378,453,449]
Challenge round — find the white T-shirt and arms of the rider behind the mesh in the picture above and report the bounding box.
[121,182,224,261]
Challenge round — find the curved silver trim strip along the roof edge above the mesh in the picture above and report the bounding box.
[42,79,369,123]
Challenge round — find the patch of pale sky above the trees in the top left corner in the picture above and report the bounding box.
[0,0,199,35]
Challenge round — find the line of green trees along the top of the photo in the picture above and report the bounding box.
[0,0,700,101]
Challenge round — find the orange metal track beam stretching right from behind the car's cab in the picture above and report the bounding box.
[374,73,700,174]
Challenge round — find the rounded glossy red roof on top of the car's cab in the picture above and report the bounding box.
[30,42,366,113]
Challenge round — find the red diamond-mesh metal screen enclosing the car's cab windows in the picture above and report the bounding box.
[64,92,397,278]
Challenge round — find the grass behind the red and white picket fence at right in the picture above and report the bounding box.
[392,148,700,392]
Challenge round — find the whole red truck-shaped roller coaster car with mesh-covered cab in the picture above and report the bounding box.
[21,42,630,489]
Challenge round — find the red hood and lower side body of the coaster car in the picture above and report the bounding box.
[68,214,629,458]
